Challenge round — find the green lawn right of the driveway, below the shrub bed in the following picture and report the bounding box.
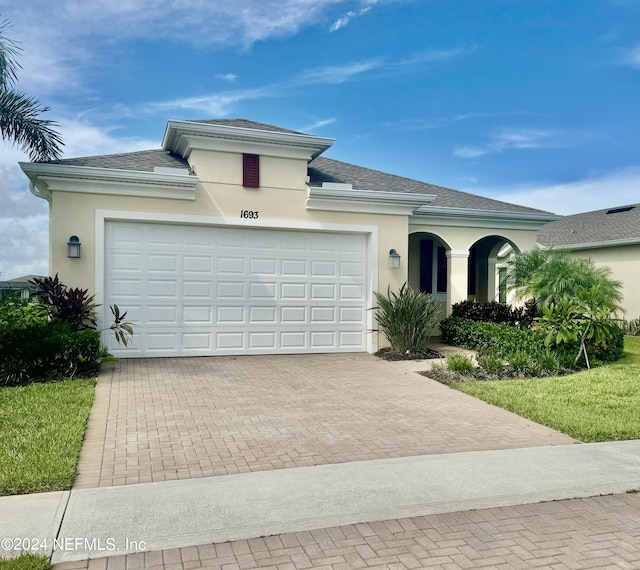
[451,336,640,442]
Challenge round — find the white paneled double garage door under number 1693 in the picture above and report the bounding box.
[105,222,368,357]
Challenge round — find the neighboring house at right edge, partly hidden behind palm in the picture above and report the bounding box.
[538,204,640,319]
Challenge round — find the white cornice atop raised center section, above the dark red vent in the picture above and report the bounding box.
[162,120,335,161]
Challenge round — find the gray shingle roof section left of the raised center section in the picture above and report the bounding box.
[50,149,190,172]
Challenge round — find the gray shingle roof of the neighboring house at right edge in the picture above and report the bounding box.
[538,204,640,248]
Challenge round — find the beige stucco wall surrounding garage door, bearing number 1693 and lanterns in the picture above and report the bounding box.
[50,151,408,346]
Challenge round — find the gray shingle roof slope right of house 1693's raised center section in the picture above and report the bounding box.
[309,157,549,214]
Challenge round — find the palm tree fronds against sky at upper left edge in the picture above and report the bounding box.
[0,20,63,161]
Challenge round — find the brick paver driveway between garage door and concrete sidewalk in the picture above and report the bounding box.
[76,354,574,487]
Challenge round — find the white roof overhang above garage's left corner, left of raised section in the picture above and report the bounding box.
[19,162,199,202]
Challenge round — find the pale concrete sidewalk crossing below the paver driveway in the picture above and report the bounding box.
[0,440,640,562]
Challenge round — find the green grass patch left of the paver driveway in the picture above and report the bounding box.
[0,380,95,492]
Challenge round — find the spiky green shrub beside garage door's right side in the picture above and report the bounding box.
[375,283,439,353]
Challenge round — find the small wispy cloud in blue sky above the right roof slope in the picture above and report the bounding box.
[453,128,585,158]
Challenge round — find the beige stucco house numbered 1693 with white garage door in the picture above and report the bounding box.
[21,119,557,357]
